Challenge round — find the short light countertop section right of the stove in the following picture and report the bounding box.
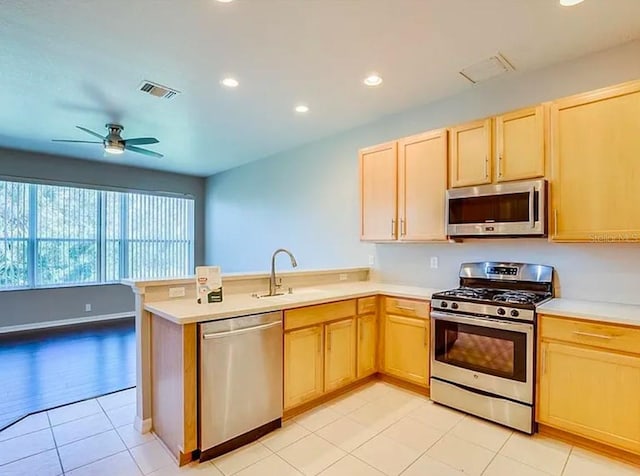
[538,298,640,326]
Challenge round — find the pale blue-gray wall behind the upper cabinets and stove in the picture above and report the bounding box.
[205,41,640,302]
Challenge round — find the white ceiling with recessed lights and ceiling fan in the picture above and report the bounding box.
[0,0,640,176]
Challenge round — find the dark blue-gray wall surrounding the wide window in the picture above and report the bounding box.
[0,149,205,328]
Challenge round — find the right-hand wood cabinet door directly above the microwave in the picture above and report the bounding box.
[496,106,545,182]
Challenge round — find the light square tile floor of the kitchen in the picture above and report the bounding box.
[0,382,640,476]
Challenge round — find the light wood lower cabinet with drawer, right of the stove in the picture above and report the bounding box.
[538,316,640,454]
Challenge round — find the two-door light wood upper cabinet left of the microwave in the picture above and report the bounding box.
[360,129,447,241]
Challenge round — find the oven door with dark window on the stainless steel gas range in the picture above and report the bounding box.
[431,311,533,404]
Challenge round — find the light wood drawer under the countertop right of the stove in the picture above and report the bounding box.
[540,315,640,354]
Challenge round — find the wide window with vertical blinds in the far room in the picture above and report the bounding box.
[0,181,194,289]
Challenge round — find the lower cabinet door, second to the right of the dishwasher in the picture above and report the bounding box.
[324,318,356,392]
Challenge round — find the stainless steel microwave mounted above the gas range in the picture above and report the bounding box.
[446,180,547,237]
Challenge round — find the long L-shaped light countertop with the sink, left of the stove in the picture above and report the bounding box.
[144,281,439,324]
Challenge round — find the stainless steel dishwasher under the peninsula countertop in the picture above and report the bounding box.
[199,312,282,461]
